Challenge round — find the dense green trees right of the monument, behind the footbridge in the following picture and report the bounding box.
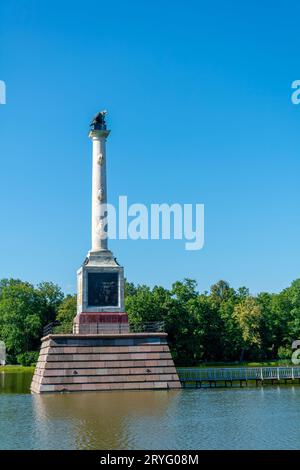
[126,279,300,365]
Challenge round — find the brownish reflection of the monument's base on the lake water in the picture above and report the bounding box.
[33,391,180,449]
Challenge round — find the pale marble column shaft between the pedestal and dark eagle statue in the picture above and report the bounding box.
[89,129,110,252]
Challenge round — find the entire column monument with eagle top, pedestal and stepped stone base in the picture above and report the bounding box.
[31,111,180,393]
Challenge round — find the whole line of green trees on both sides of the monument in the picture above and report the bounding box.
[0,279,300,365]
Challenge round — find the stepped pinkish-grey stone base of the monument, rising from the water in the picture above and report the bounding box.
[31,333,181,393]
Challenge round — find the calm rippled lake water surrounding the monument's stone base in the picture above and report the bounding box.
[0,373,300,449]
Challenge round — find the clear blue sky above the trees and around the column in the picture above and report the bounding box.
[0,0,300,293]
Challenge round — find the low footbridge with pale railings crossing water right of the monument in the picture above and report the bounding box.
[177,367,300,388]
